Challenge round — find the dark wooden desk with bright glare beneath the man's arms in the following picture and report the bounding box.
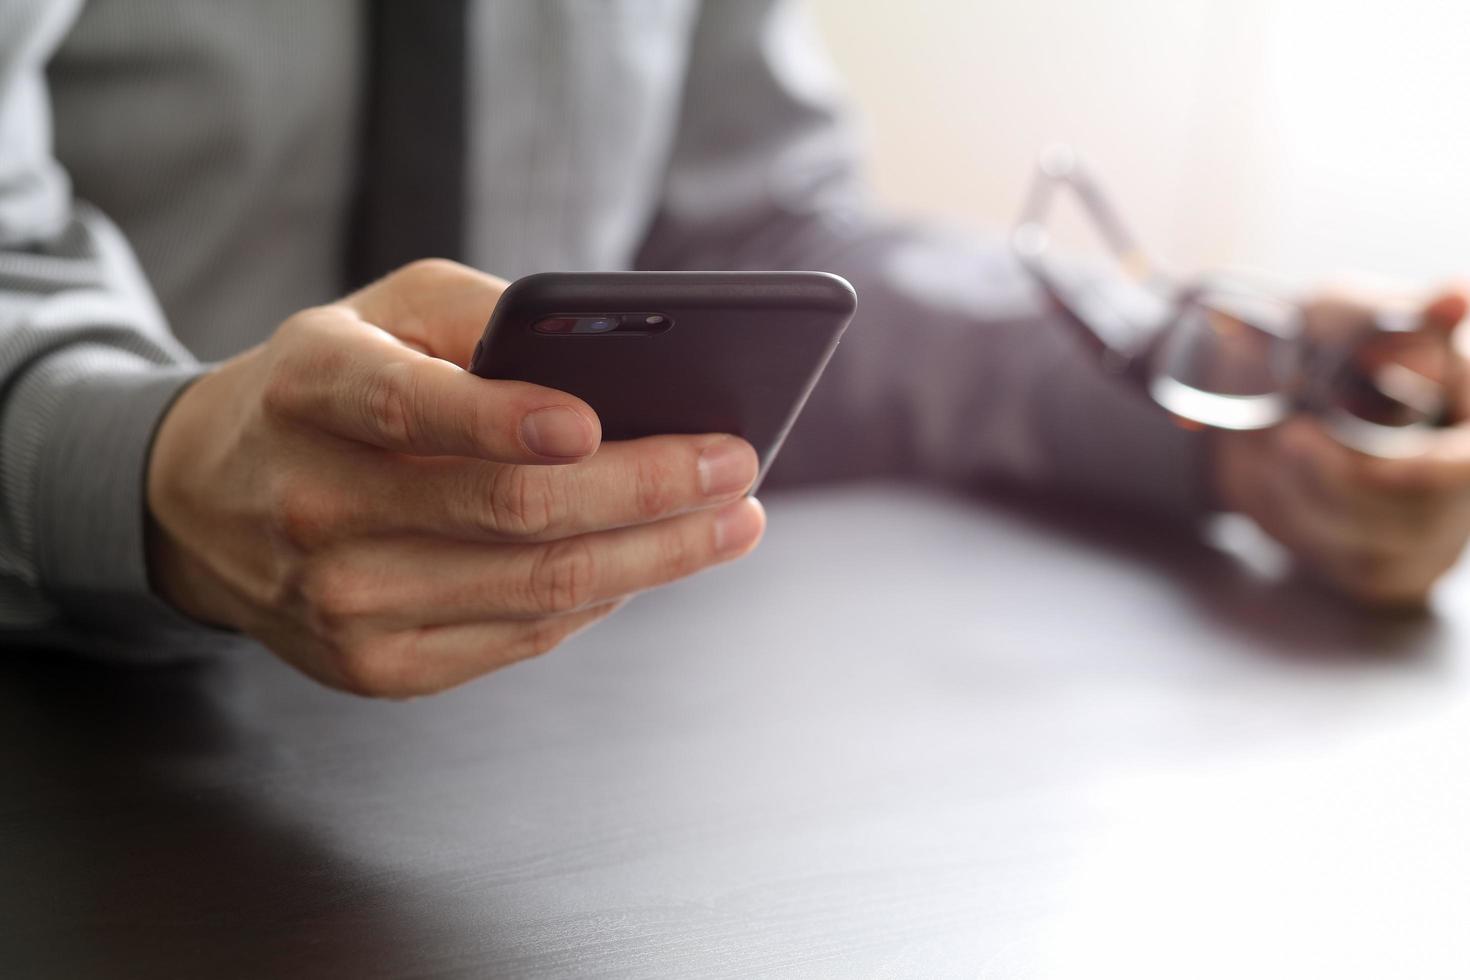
[0,488,1470,977]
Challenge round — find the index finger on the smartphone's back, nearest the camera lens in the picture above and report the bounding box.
[265,309,601,463]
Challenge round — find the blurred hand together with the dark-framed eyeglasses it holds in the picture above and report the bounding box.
[1013,147,1470,605]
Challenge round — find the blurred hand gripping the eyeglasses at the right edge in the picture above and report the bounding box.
[1214,291,1470,607]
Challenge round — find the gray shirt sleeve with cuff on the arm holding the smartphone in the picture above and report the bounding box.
[0,0,239,658]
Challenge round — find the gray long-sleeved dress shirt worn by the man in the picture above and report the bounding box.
[0,0,1202,655]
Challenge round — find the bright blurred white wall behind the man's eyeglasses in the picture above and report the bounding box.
[811,0,1470,285]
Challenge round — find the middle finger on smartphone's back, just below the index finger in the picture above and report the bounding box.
[321,435,759,542]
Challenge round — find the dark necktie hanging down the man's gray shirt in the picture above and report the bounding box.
[347,0,469,288]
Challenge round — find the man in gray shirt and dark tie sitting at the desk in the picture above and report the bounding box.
[0,0,1470,696]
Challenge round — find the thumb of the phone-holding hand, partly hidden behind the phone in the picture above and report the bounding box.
[341,259,507,366]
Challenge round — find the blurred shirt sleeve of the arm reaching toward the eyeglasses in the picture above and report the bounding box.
[638,0,1207,519]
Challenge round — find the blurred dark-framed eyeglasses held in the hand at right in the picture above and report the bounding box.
[1011,145,1457,457]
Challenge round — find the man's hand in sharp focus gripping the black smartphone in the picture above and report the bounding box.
[148,260,764,696]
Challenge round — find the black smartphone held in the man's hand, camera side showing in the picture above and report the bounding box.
[469,272,857,483]
